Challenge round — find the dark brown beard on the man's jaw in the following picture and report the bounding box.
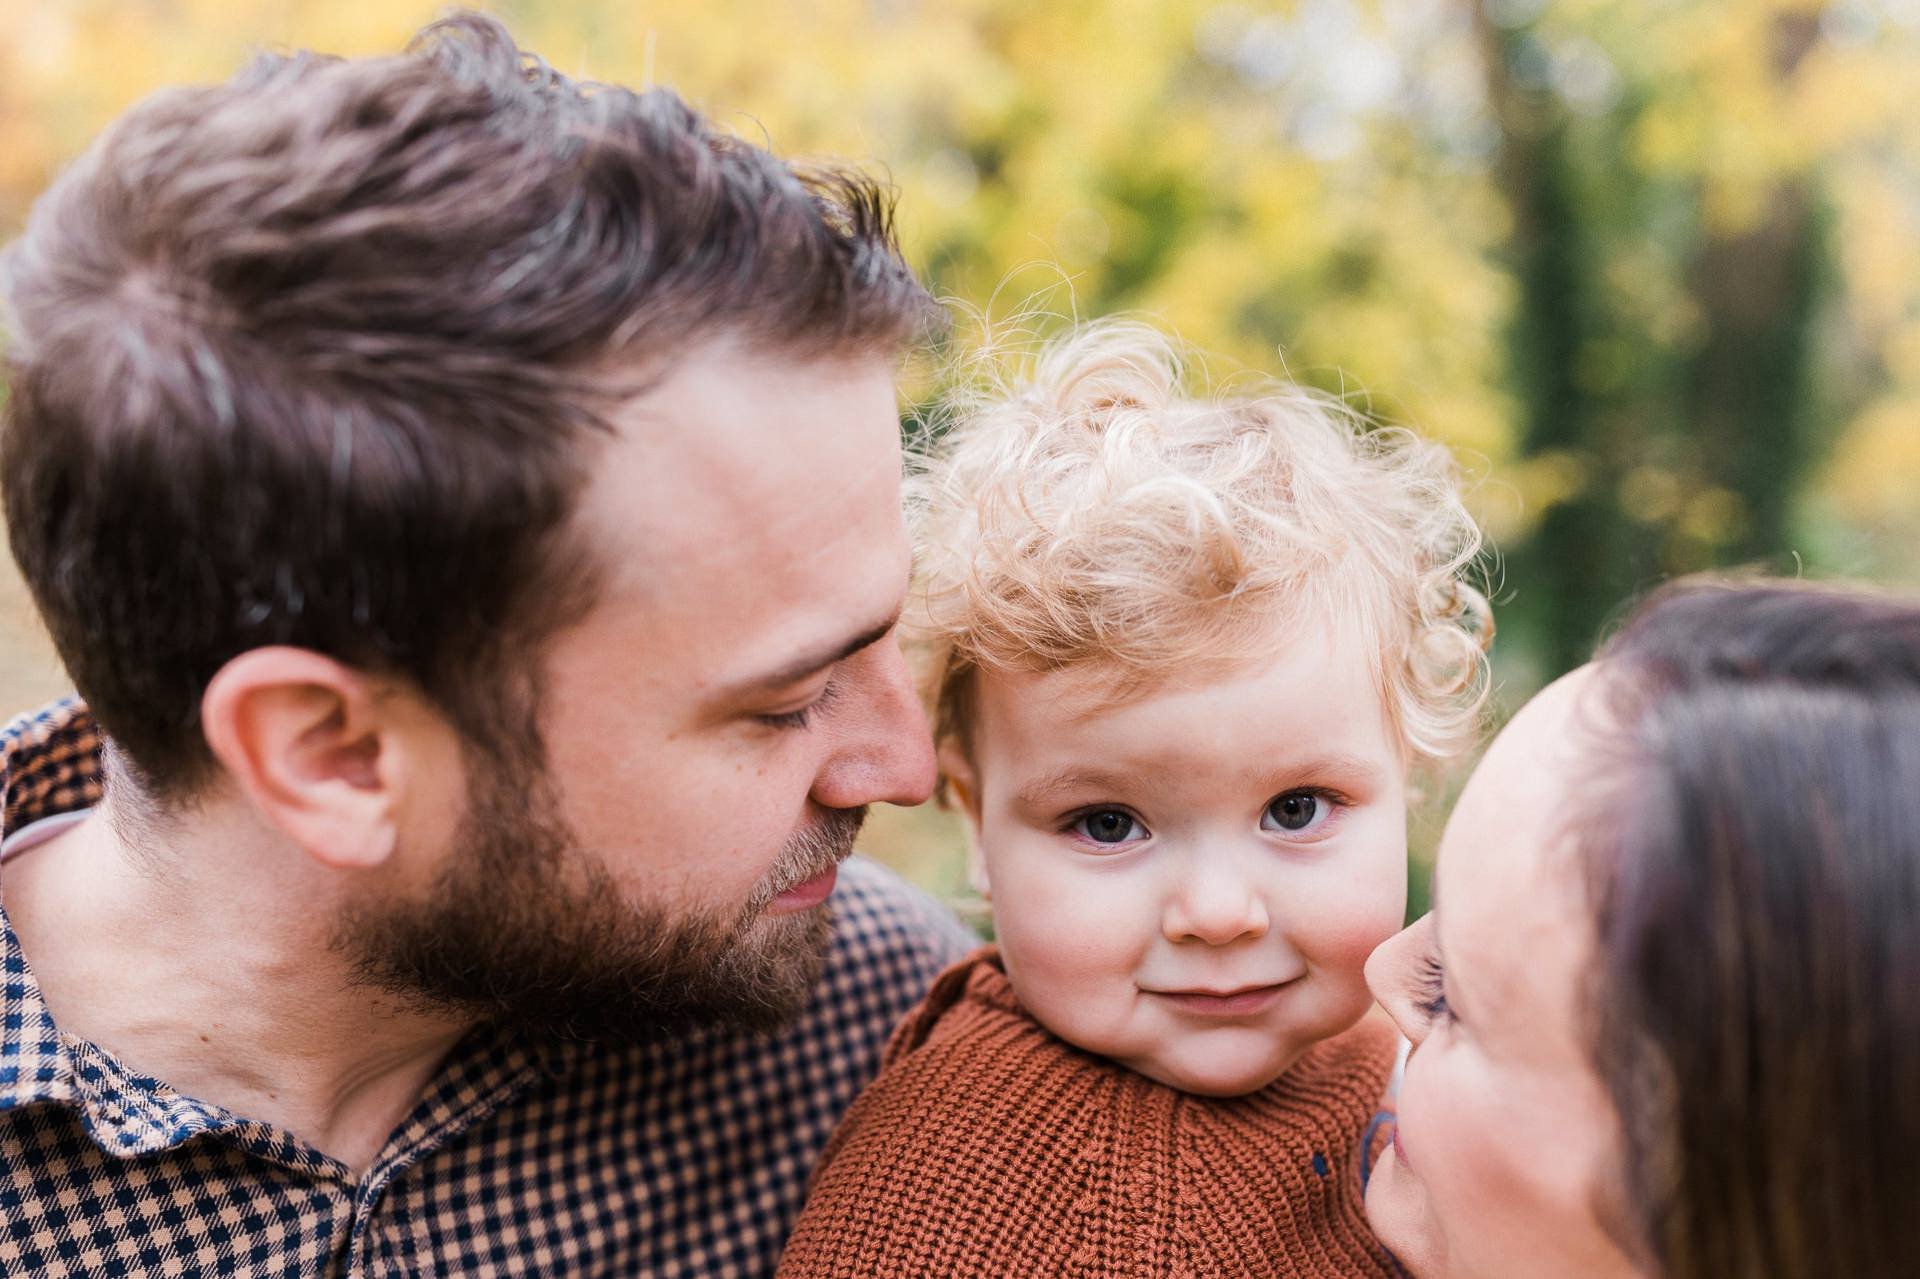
[336,741,866,1043]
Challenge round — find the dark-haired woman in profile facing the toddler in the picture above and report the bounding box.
[1367,584,1920,1279]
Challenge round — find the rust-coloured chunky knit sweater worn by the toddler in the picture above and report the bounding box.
[780,947,1394,1279]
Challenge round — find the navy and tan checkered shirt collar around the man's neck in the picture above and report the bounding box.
[0,699,584,1193]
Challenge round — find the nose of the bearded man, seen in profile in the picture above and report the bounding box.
[812,636,935,808]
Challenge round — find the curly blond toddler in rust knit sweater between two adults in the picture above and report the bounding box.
[780,325,1490,1279]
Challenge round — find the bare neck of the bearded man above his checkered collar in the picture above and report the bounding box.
[0,810,467,1171]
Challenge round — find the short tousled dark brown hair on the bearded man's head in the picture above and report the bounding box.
[0,15,933,793]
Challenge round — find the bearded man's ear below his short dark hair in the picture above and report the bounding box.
[200,647,407,870]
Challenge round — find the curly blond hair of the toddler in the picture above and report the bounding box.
[906,321,1492,759]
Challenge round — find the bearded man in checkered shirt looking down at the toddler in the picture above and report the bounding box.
[0,15,966,1275]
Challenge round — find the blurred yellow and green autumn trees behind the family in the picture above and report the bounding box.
[0,0,1920,902]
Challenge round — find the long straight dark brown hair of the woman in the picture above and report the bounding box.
[1578,582,1920,1279]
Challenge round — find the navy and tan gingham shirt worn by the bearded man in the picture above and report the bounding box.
[0,701,972,1279]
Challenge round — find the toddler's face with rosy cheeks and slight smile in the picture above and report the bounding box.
[948,622,1407,1095]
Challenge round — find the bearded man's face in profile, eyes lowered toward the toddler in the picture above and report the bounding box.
[346,342,933,1035]
